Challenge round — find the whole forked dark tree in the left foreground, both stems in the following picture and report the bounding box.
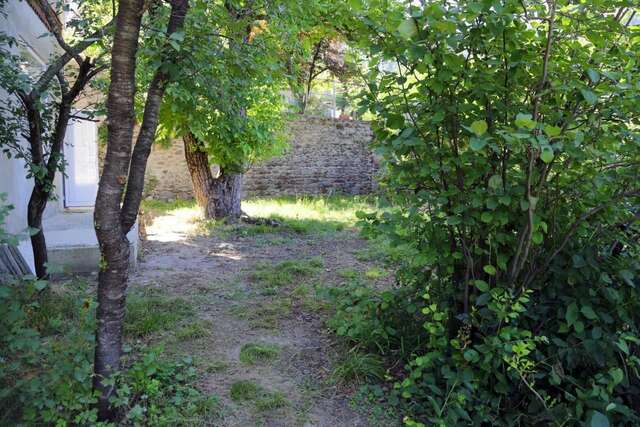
[93,0,189,420]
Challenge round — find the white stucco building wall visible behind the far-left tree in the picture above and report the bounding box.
[0,0,63,237]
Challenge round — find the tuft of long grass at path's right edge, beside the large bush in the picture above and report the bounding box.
[332,349,385,384]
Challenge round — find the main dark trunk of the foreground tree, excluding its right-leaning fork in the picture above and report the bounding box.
[93,0,144,420]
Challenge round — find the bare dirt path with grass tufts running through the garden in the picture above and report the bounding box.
[131,206,384,426]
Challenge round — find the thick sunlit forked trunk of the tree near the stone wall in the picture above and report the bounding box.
[182,133,242,219]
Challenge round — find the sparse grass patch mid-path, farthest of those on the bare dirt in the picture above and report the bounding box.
[249,257,324,289]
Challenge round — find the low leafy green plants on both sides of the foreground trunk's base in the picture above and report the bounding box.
[0,280,219,425]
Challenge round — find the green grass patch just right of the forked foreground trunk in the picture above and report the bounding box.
[124,290,195,337]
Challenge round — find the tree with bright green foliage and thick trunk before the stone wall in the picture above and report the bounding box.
[150,2,283,218]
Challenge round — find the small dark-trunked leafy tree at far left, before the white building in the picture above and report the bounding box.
[0,0,111,278]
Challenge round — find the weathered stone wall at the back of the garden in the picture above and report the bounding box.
[146,117,377,199]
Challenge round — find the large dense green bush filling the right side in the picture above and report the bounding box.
[336,0,640,426]
